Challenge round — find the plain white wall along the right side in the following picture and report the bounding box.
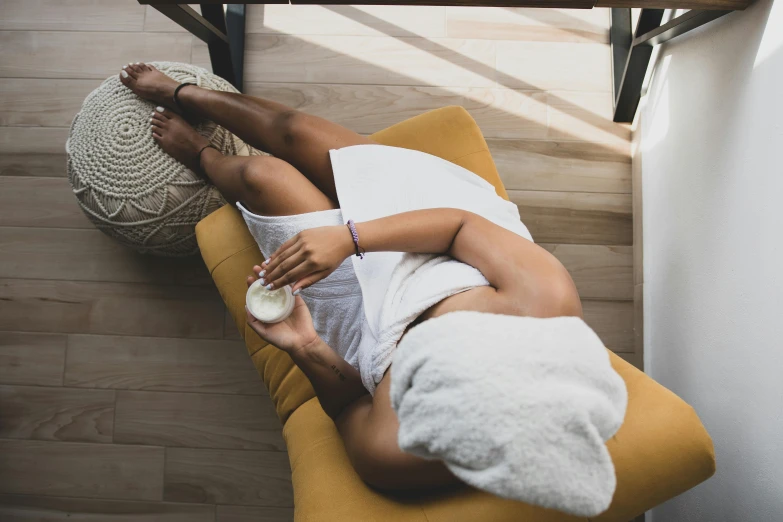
[641,0,783,522]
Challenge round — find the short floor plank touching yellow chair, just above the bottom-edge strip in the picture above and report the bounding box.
[163,448,293,507]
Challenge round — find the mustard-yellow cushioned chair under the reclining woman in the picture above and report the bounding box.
[196,107,715,522]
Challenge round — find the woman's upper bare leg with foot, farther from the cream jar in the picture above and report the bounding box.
[121,64,373,204]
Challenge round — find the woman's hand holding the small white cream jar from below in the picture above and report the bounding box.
[245,265,320,356]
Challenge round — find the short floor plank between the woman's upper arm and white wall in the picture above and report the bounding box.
[540,243,633,300]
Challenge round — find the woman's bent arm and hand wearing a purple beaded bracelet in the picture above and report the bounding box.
[264,208,581,317]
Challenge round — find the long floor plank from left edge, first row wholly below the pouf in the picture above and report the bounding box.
[0,279,223,339]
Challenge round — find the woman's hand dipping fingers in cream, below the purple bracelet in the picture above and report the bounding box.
[259,225,354,291]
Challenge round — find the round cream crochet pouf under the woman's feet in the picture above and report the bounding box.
[65,62,265,256]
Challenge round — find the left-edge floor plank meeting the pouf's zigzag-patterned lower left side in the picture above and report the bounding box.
[0,176,93,228]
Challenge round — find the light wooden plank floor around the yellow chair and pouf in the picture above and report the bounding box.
[0,0,641,522]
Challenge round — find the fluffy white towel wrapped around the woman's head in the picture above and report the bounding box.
[391,312,628,517]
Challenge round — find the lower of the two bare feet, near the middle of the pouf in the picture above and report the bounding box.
[150,106,209,173]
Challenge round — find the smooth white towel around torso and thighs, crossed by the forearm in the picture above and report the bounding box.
[329,145,532,394]
